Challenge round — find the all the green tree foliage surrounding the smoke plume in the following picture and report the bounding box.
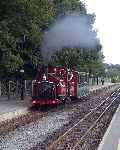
[0,0,102,76]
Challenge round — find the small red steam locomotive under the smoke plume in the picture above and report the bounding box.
[32,66,89,106]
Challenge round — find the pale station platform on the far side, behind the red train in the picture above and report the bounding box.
[0,83,117,122]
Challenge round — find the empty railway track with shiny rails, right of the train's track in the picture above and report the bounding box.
[48,88,120,150]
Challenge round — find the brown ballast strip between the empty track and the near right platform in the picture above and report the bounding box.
[76,98,120,150]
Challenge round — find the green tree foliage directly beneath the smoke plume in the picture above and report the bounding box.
[51,48,104,74]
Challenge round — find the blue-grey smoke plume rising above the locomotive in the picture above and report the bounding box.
[41,15,100,62]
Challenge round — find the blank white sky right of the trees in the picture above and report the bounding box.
[82,0,120,64]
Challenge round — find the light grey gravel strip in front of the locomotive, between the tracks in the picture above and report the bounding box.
[0,112,70,150]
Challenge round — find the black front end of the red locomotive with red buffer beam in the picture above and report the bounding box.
[32,81,60,106]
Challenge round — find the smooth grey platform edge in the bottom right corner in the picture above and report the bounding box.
[98,105,120,150]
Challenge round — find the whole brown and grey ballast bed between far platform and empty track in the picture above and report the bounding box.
[0,86,117,150]
